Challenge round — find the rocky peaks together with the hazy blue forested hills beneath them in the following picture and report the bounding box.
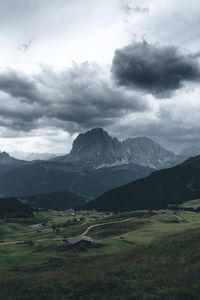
[0,128,195,205]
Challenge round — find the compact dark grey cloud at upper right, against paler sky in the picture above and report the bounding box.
[112,41,200,97]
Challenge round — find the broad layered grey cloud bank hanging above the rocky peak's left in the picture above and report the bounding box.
[0,63,149,132]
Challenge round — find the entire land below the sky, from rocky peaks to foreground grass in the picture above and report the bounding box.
[0,128,200,300]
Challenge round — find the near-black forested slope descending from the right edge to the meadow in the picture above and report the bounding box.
[84,156,200,211]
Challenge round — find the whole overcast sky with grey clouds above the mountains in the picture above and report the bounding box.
[0,0,200,153]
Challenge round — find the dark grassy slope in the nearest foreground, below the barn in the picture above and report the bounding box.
[0,229,200,300]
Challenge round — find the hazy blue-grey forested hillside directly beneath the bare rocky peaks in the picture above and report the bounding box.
[0,161,152,199]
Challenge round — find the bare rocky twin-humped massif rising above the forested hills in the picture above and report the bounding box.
[57,128,179,169]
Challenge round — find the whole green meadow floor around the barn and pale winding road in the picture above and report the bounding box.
[0,210,200,300]
